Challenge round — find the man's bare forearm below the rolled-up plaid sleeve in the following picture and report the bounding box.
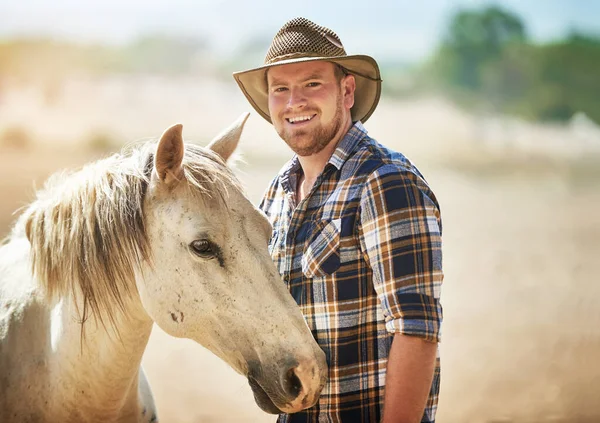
[383,334,437,423]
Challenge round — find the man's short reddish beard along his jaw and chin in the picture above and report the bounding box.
[277,93,343,157]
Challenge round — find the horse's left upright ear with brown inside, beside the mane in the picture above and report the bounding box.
[154,123,184,183]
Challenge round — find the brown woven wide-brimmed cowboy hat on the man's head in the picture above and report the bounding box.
[233,18,381,123]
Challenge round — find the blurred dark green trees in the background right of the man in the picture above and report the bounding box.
[421,7,600,122]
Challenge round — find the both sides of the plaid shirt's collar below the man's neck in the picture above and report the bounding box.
[279,121,367,192]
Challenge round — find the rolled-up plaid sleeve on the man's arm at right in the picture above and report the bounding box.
[359,165,443,342]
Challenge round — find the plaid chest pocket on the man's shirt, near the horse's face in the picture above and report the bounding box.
[302,219,342,278]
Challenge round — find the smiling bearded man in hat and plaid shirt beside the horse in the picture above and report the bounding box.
[234,18,443,423]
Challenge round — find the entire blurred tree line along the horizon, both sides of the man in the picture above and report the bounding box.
[0,6,600,125]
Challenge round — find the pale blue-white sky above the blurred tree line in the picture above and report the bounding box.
[0,0,600,62]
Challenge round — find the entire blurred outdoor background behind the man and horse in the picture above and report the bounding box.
[0,0,600,423]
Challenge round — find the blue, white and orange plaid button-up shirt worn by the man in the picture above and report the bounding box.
[260,122,443,423]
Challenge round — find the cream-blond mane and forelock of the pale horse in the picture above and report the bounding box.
[13,143,240,325]
